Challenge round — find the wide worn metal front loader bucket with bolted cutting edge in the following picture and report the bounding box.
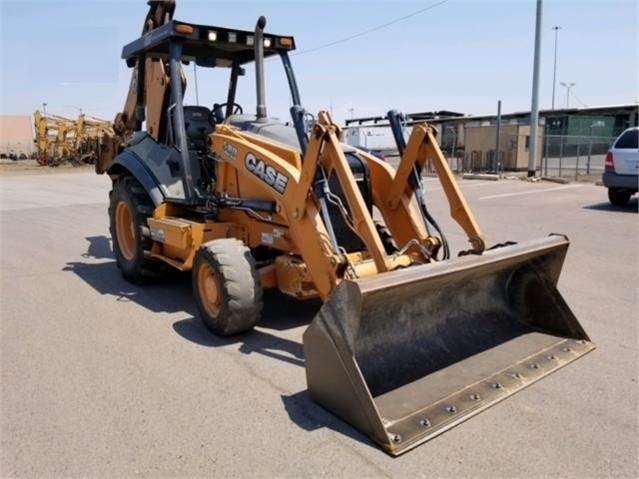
[304,236,595,455]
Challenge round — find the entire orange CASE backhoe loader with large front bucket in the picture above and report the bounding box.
[96,1,594,455]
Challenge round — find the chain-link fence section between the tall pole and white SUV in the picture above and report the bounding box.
[540,135,615,181]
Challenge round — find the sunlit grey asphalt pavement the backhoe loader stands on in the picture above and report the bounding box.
[0,172,639,478]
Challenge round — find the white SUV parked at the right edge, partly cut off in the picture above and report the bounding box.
[602,127,639,206]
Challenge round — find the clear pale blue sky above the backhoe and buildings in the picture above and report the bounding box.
[0,0,639,123]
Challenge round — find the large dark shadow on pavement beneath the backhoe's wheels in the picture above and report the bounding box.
[62,236,322,367]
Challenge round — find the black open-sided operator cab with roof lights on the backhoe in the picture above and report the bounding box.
[122,17,301,205]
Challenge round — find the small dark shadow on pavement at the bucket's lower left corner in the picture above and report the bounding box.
[282,390,377,449]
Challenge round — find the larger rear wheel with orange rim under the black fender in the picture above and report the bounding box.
[109,175,163,283]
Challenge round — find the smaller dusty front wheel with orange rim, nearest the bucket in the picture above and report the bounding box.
[192,238,263,336]
